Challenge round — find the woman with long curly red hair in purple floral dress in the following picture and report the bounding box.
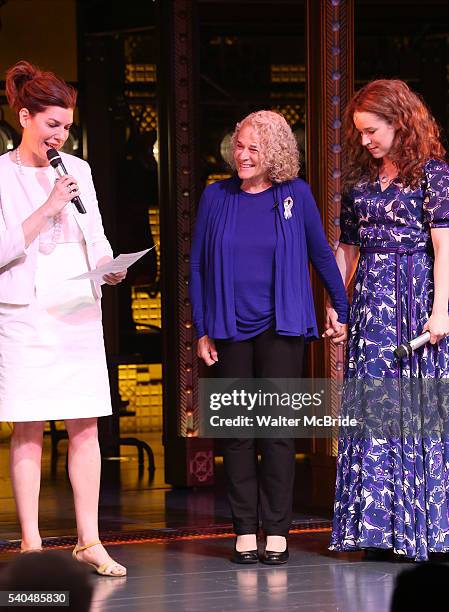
[325,80,449,561]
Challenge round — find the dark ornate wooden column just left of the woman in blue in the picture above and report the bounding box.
[158,0,214,486]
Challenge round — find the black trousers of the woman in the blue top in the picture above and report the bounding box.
[211,329,304,536]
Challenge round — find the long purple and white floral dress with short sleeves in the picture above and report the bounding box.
[330,159,449,560]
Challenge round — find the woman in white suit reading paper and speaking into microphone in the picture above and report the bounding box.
[0,61,126,576]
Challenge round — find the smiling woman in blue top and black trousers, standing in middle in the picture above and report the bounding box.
[190,111,348,564]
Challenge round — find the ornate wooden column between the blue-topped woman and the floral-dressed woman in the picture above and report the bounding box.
[306,0,354,507]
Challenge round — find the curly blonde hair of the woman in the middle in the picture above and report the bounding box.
[229,110,299,183]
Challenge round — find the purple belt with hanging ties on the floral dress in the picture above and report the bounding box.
[360,245,431,356]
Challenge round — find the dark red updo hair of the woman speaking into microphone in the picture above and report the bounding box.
[6,60,77,115]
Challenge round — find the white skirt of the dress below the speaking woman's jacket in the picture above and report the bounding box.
[0,242,112,422]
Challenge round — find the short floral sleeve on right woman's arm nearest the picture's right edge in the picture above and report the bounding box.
[423,159,449,228]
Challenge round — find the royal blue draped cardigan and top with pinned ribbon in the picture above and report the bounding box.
[190,177,349,340]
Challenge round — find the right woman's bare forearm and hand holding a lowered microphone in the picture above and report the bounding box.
[423,227,449,344]
